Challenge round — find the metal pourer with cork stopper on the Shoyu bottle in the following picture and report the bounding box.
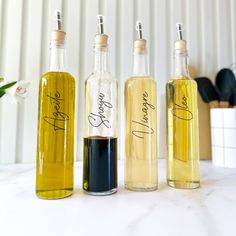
[95,15,108,48]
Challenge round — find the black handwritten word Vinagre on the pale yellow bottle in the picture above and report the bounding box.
[132,91,155,139]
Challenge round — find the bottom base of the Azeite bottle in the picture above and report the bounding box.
[36,189,73,200]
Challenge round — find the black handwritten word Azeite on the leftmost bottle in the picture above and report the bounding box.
[43,91,69,131]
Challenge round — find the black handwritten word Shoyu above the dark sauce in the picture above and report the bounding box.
[88,93,113,128]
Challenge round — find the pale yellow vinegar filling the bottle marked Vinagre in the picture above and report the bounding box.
[125,77,157,191]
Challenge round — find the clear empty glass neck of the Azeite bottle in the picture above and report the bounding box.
[50,45,65,72]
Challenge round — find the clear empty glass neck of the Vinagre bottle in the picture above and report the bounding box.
[133,53,149,76]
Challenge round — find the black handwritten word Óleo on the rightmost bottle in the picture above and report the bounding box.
[172,96,193,121]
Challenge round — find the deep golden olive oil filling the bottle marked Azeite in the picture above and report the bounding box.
[36,72,75,199]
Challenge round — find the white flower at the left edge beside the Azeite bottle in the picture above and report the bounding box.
[5,80,30,103]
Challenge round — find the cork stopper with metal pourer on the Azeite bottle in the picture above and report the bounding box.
[51,11,66,46]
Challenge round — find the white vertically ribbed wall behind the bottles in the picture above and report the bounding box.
[0,0,236,163]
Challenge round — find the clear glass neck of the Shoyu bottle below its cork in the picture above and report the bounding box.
[94,47,109,73]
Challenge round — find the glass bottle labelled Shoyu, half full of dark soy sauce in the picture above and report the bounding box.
[83,15,117,195]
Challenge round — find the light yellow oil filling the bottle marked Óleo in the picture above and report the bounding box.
[166,77,200,189]
